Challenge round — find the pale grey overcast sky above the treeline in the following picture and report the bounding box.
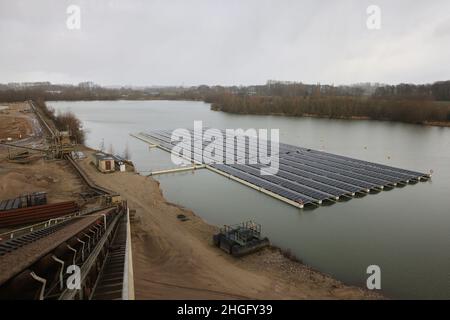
[0,0,450,85]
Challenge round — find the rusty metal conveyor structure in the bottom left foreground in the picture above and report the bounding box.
[0,202,134,300]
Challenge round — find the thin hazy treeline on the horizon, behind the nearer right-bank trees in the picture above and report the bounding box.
[0,80,450,102]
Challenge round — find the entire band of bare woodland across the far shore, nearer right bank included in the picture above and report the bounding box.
[0,81,450,125]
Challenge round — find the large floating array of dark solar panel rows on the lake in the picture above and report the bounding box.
[137,129,430,208]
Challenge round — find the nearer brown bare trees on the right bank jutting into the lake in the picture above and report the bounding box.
[206,94,450,123]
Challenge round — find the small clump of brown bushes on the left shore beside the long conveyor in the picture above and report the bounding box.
[35,98,86,144]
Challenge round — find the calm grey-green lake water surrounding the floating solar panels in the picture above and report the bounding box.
[49,101,450,299]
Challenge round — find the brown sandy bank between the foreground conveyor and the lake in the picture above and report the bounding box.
[76,151,380,299]
